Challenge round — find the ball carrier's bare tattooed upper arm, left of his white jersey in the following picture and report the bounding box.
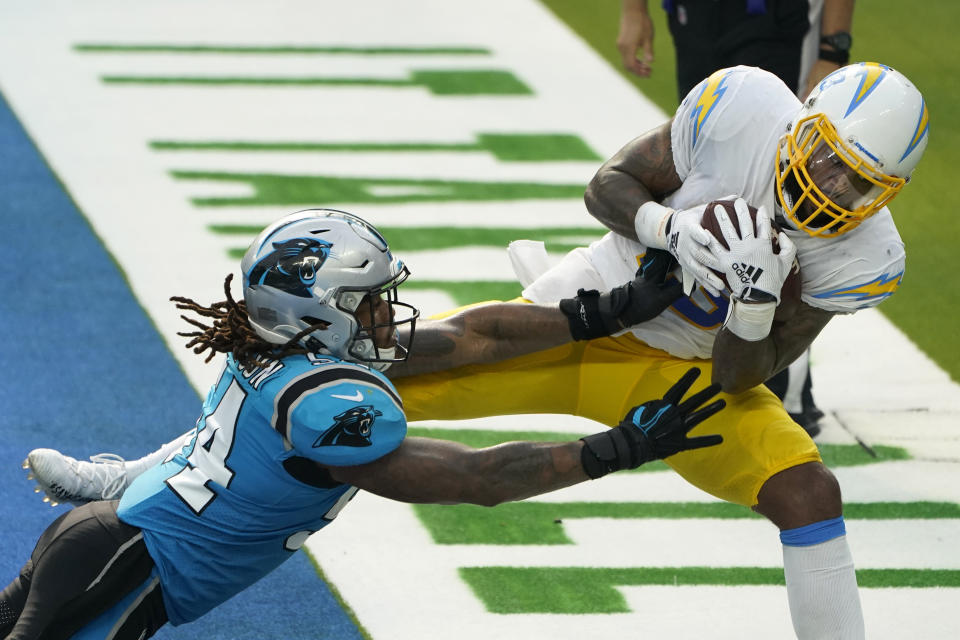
[584,120,682,240]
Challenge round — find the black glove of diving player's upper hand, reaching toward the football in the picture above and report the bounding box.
[560,249,683,340]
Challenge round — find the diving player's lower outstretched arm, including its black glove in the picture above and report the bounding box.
[328,368,724,506]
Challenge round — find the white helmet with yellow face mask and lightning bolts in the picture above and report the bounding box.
[777,62,930,237]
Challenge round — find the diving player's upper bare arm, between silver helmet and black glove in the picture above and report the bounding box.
[386,302,573,378]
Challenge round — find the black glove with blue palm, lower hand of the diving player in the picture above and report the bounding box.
[580,367,726,478]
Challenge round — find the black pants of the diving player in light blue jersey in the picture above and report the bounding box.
[0,500,167,640]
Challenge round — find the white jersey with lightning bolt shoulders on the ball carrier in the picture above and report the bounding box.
[523,67,905,358]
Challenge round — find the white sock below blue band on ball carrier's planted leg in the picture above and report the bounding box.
[783,530,864,640]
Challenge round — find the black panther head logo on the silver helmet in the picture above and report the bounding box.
[247,238,332,298]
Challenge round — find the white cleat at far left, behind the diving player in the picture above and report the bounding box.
[23,449,127,507]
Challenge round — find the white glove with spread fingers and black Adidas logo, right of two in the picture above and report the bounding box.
[710,198,797,304]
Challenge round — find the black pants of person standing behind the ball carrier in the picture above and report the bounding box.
[664,0,810,100]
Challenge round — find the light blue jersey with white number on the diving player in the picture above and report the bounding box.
[117,355,407,625]
